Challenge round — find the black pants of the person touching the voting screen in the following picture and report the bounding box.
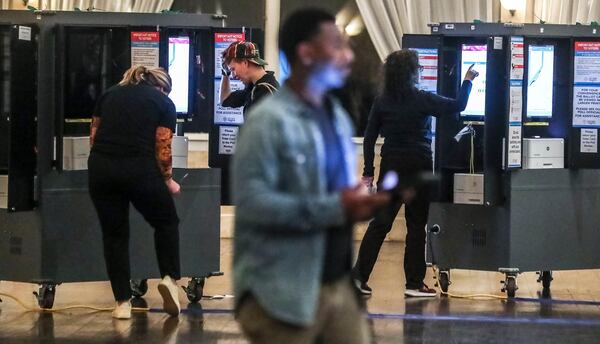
[353,155,432,289]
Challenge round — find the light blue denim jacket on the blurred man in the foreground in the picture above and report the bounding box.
[232,87,356,326]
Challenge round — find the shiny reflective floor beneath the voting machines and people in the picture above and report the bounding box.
[0,240,600,343]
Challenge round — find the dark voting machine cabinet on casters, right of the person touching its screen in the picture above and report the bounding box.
[403,23,600,297]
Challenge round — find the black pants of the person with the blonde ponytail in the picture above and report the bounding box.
[88,153,180,301]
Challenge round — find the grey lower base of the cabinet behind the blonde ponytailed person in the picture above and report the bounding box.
[0,169,220,283]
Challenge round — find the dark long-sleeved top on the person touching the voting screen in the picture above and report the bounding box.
[363,81,472,177]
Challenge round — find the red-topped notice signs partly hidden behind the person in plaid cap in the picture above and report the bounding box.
[214,32,246,155]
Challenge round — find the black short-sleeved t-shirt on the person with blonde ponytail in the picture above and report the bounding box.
[92,83,177,157]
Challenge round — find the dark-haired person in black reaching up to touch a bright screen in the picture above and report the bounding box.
[353,50,478,297]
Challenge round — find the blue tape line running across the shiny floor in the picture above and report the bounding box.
[150,308,600,327]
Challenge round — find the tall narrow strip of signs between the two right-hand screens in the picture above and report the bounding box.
[506,37,524,168]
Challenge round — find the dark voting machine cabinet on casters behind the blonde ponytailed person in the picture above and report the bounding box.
[0,11,237,308]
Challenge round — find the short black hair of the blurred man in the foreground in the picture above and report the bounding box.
[279,7,335,65]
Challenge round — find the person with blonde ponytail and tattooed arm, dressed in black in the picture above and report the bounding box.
[88,66,180,319]
